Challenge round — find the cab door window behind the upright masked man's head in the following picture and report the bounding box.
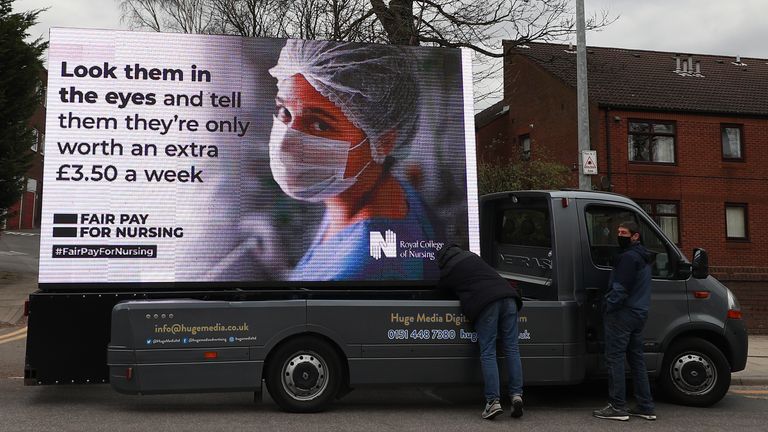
[586,206,677,279]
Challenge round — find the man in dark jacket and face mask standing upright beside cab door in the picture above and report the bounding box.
[592,221,656,421]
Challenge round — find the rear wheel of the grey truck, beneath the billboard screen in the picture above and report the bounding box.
[266,336,342,412]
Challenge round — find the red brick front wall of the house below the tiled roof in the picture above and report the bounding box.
[593,110,768,268]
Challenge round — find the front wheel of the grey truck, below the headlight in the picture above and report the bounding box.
[660,338,731,407]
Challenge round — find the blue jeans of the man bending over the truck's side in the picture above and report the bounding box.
[474,297,523,401]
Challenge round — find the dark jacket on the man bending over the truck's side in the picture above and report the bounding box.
[437,245,523,321]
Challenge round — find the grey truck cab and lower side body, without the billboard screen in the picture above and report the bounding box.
[108,191,747,411]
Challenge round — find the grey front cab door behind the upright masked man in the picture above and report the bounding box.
[577,200,689,372]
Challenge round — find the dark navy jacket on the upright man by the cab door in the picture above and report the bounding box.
[605,243,653,319]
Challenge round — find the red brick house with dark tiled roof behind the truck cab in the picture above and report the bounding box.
[476,43,768,333]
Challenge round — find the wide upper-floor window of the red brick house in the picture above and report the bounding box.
[628,120,675,163]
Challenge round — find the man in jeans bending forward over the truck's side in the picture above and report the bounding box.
[437,245,523,420]
